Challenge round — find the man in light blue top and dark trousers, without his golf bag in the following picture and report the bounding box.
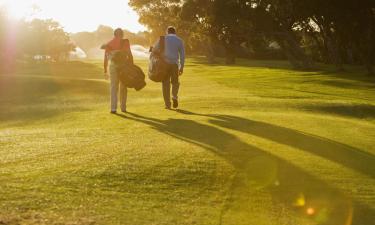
[154,27,185,109]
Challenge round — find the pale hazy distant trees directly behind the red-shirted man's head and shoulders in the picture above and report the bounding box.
[71,25,150,58]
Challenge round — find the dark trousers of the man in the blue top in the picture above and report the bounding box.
[163,64,180,107]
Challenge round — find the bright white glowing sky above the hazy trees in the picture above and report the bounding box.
[0,0,146,33]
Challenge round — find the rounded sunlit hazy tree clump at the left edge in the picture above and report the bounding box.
[0,11,75,67]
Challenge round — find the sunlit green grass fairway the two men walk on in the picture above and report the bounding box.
[0,59,375,225]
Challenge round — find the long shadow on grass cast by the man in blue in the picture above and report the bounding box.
[206,116,375,178]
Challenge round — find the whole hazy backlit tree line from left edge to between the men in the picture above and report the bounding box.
[0,7,150,66]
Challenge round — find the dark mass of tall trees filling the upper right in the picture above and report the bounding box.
[129,0,375,74]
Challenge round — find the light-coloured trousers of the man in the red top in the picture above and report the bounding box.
[109,64,128,111]
